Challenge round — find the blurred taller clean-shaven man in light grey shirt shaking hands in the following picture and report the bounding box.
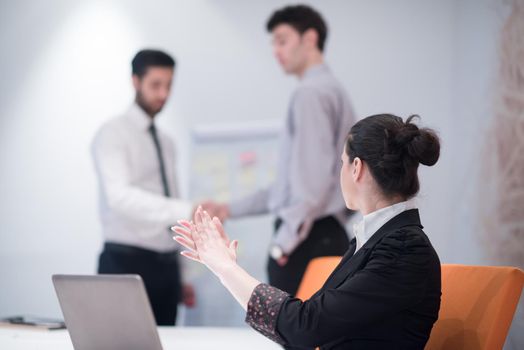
[204,5,355,294]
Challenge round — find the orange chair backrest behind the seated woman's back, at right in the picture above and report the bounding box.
[426,264,524,350]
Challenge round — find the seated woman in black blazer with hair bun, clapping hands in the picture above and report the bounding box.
[173,114,441,349]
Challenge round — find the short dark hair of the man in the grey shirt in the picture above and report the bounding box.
[266,5,327,51]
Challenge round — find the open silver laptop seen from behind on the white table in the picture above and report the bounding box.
[53,275,162,350]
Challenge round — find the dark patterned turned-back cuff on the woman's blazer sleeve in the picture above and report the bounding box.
[246,283,289,345]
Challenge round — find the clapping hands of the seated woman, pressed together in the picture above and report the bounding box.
[171,207,238,277]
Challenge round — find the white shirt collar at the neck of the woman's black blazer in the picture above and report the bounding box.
[353,199,416,253]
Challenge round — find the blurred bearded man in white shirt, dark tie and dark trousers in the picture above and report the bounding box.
[92,50,194,325]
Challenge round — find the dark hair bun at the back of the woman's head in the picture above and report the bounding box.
[404,115,440,166]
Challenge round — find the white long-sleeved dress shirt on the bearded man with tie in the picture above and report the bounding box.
[92,104,192,252]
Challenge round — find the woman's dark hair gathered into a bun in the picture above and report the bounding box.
[346,114,440,199]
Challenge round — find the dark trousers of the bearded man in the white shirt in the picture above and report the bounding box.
[98,243,182,326]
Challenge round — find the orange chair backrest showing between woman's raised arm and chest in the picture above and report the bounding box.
[296,256,342,300]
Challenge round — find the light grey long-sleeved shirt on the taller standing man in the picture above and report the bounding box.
[230,64,355,254]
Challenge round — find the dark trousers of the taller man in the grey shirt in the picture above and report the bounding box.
[267,216,349,295]
